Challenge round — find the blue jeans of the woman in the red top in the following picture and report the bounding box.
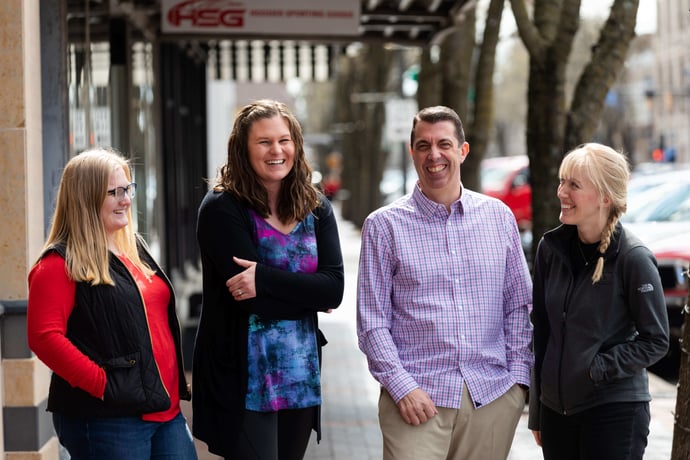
[53,413,197,460]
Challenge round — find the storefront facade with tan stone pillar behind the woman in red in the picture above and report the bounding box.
[0,0,466,460]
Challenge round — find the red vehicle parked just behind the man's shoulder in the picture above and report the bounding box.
[480,155,532,231]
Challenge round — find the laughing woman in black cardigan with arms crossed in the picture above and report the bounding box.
[192,100,344,460]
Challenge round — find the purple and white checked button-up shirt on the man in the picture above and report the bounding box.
[357,187,534,408]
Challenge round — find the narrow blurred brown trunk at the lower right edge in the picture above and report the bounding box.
[671,271,690,460]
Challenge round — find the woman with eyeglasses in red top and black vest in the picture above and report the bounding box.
[27,148,197,460]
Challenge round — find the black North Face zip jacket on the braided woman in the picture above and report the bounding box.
[529,222,669,430]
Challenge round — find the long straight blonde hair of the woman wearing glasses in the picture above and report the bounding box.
[41,147,154,285]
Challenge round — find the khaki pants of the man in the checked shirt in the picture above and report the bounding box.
[379,385,525,460]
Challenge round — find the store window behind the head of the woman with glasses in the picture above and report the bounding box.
[68,37,164,260]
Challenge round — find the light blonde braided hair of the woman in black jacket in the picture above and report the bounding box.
[558,142,630,283]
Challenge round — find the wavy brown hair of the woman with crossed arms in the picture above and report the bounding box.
[214,99,320,223]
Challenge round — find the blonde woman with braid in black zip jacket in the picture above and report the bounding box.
[529,143,669,460]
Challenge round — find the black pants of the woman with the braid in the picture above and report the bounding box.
[541,402,650,460]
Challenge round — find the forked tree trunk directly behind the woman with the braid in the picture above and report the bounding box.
[511,0,639,255]
